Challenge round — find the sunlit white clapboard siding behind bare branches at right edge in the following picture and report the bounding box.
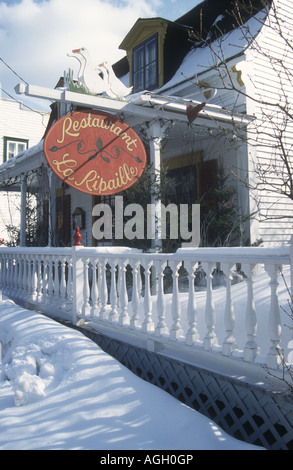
[247,0,293,244]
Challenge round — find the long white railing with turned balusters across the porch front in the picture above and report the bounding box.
[0,245,291,369]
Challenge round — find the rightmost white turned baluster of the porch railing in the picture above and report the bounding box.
[265,265,283,369]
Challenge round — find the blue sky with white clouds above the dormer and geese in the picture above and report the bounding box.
[0,0,200,109]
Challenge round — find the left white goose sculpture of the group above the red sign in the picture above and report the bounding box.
[72,47,106,95]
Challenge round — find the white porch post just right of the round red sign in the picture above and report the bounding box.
[147,119,170,251]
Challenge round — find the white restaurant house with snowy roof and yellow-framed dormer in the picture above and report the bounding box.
[0,0,293,246]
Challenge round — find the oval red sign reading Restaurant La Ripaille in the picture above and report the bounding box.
[44,111,146,196]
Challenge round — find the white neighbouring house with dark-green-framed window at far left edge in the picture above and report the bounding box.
[0,94,49,243]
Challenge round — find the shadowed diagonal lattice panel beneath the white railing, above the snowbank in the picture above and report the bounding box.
[77,329,293,450]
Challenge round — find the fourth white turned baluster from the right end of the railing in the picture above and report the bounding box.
[202,263,218,351]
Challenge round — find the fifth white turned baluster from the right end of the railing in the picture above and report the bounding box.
[184,261,199,346]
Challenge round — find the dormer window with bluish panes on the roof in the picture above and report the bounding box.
[133,34,158,93]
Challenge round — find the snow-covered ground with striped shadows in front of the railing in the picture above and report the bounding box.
[0,299,264,451]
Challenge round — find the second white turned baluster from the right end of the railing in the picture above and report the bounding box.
[242,264,259,362]
